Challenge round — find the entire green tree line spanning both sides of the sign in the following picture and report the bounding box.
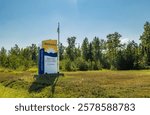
[0,22,150,71]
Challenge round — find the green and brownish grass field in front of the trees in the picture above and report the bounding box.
[0,69,150,98]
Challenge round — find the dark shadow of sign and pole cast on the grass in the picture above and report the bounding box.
[28,75,59,97]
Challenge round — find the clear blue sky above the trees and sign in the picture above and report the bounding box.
[0,0,150,49]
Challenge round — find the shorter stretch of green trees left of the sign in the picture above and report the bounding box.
[0,44,38,70]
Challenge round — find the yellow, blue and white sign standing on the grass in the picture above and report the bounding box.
[39,40,58,74]
